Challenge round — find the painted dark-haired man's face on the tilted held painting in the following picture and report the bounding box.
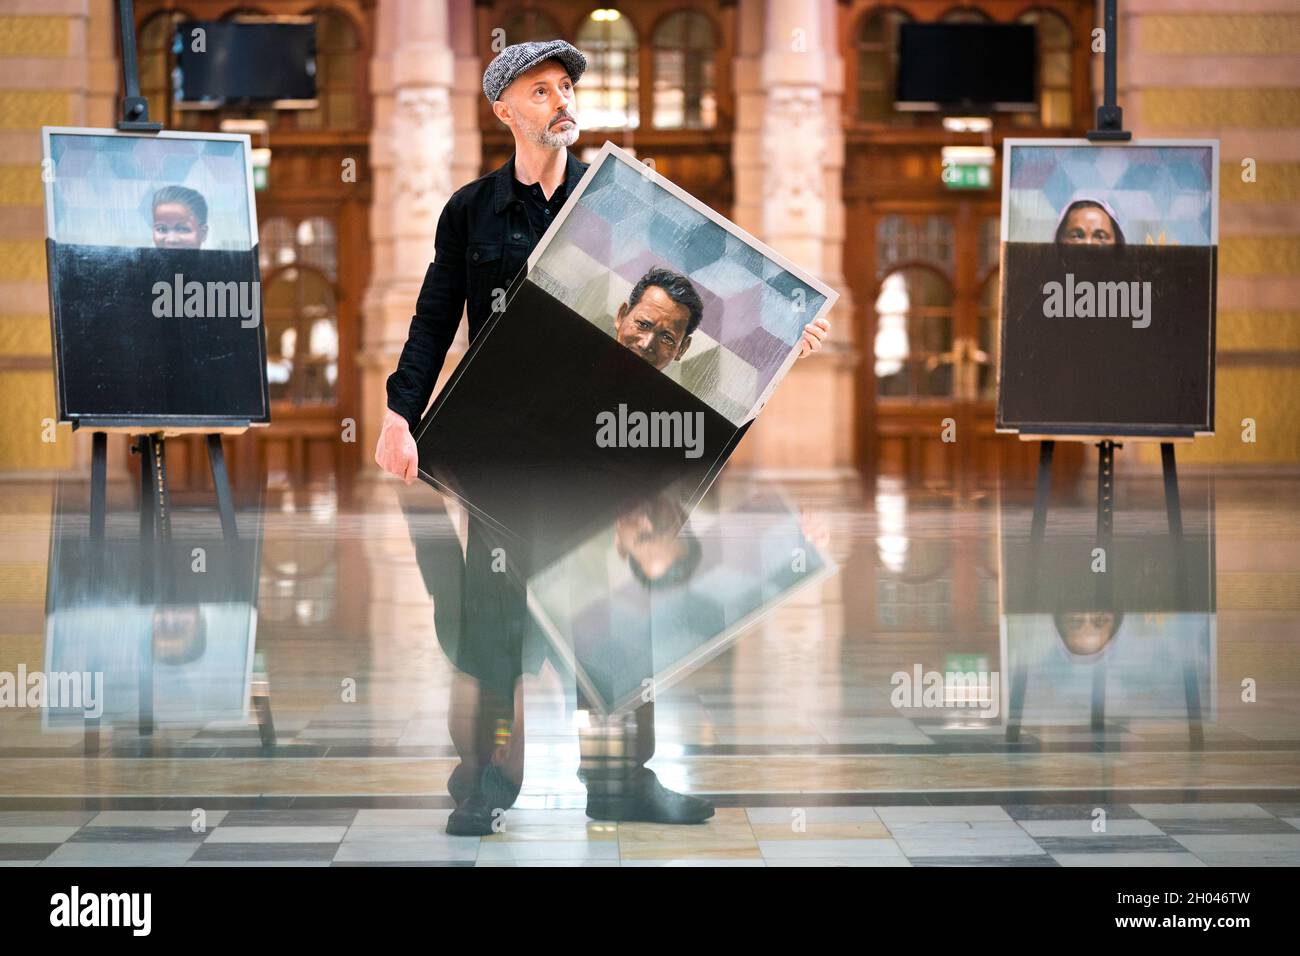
[614,268,705,372]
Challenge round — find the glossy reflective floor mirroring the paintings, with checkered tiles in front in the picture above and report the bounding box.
[0,476,1300,866]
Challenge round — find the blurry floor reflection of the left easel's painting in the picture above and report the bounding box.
[43,485,261,727]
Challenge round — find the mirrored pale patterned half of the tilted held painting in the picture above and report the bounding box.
[528,492,833,713]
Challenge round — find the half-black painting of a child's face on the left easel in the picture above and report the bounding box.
[43,127,270,427]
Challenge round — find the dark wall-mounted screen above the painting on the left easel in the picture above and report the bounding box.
[173,17,317,109]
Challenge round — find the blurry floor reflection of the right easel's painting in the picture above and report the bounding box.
[998,488,1217,732]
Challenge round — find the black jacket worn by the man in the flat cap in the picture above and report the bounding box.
[387,152,588,432]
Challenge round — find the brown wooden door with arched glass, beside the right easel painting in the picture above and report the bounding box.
[850,196,1073,490]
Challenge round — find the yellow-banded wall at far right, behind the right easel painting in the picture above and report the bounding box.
[1119,7,1300,468]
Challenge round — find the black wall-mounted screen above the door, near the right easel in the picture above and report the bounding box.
[894,23,1037,112]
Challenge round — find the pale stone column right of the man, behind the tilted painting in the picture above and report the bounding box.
[733,0,858,477]
